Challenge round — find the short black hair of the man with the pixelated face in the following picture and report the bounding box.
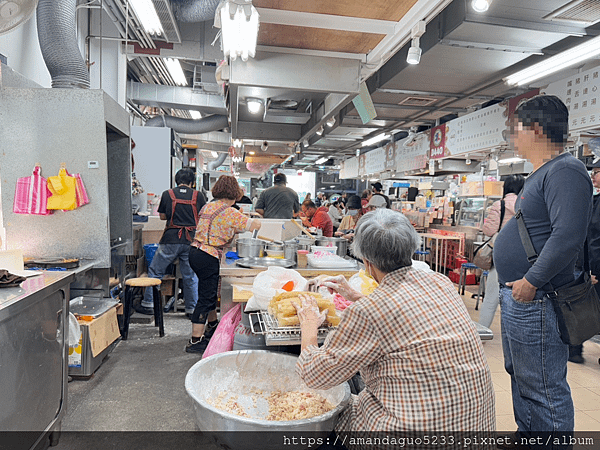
[515,95,569,144]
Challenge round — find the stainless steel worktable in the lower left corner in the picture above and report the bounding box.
[0,262,94,450]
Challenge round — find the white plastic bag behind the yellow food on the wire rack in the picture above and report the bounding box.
[246,267,308,311]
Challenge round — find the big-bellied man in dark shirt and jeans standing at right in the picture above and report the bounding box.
[494,95,592,437]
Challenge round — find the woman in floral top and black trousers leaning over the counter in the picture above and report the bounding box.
[185,175,260,353]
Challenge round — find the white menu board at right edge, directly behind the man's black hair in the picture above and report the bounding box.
[544,67,600,132]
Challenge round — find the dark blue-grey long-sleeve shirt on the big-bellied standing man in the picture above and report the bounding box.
[494,153,592,290]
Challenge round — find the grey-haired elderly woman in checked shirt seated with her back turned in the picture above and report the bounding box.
[295,208,496,433]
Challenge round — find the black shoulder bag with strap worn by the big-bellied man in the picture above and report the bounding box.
[515,210,600,345]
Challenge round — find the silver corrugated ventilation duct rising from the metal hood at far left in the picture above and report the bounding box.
[36,0,90,89]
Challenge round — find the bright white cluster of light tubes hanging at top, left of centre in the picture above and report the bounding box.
[215,1,258,61]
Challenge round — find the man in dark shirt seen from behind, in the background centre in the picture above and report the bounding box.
[254,173,300,219]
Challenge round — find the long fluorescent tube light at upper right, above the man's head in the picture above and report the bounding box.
[504,37,600,86]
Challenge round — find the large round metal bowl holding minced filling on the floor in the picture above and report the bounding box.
[185,350,350,450]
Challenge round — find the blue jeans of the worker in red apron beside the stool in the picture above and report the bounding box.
[142,244,198,314]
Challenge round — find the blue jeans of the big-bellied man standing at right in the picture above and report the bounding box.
[500,285,575,435]
